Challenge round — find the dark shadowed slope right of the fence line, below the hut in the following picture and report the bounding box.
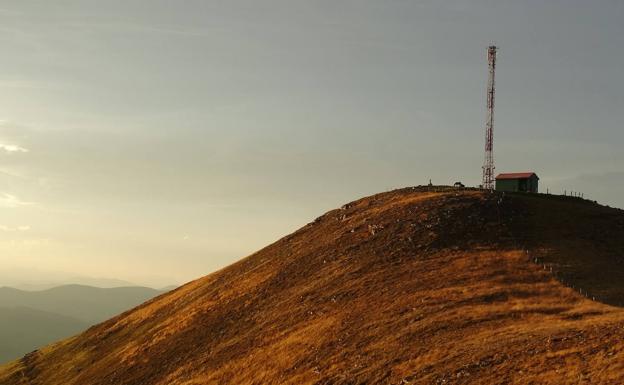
[507,194,624,306]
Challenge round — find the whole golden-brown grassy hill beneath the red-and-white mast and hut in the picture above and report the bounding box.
[0,189,624,385]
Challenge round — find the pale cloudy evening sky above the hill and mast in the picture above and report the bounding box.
[0,0,624,287]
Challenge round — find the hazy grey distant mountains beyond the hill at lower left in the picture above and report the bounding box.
[0,285,173,363]
